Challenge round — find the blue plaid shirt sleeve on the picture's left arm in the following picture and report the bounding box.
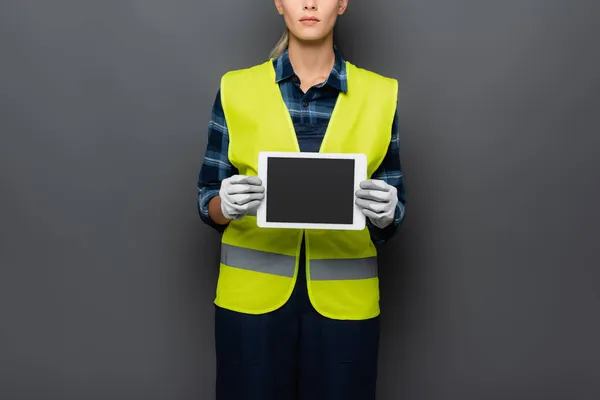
[198,90,238,232]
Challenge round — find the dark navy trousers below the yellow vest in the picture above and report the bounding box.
[215,236,379,400]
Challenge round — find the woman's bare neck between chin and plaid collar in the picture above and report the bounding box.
[288,32,335,79]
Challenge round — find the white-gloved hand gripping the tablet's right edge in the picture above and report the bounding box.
[356,179,398,229]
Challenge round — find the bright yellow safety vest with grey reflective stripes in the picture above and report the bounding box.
[215,60,398,320]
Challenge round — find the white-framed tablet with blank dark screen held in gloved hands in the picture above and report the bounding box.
[256,152,367,230]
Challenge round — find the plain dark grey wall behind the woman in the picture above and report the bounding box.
[0,0,600,400]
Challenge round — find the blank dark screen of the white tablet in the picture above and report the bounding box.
[266,157,355,225]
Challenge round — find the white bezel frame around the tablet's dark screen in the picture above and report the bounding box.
[256,151,367,230]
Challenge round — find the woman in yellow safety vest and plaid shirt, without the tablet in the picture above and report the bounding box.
[198,0,405,400]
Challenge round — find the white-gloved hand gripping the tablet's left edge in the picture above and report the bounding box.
[219,175,265,219]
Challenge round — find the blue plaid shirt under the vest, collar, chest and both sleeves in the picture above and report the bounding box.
[198,48,406,244]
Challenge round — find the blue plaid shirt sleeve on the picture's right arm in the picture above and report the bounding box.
[367,104,406,244]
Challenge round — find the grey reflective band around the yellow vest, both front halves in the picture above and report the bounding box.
[221,243,377,281]
